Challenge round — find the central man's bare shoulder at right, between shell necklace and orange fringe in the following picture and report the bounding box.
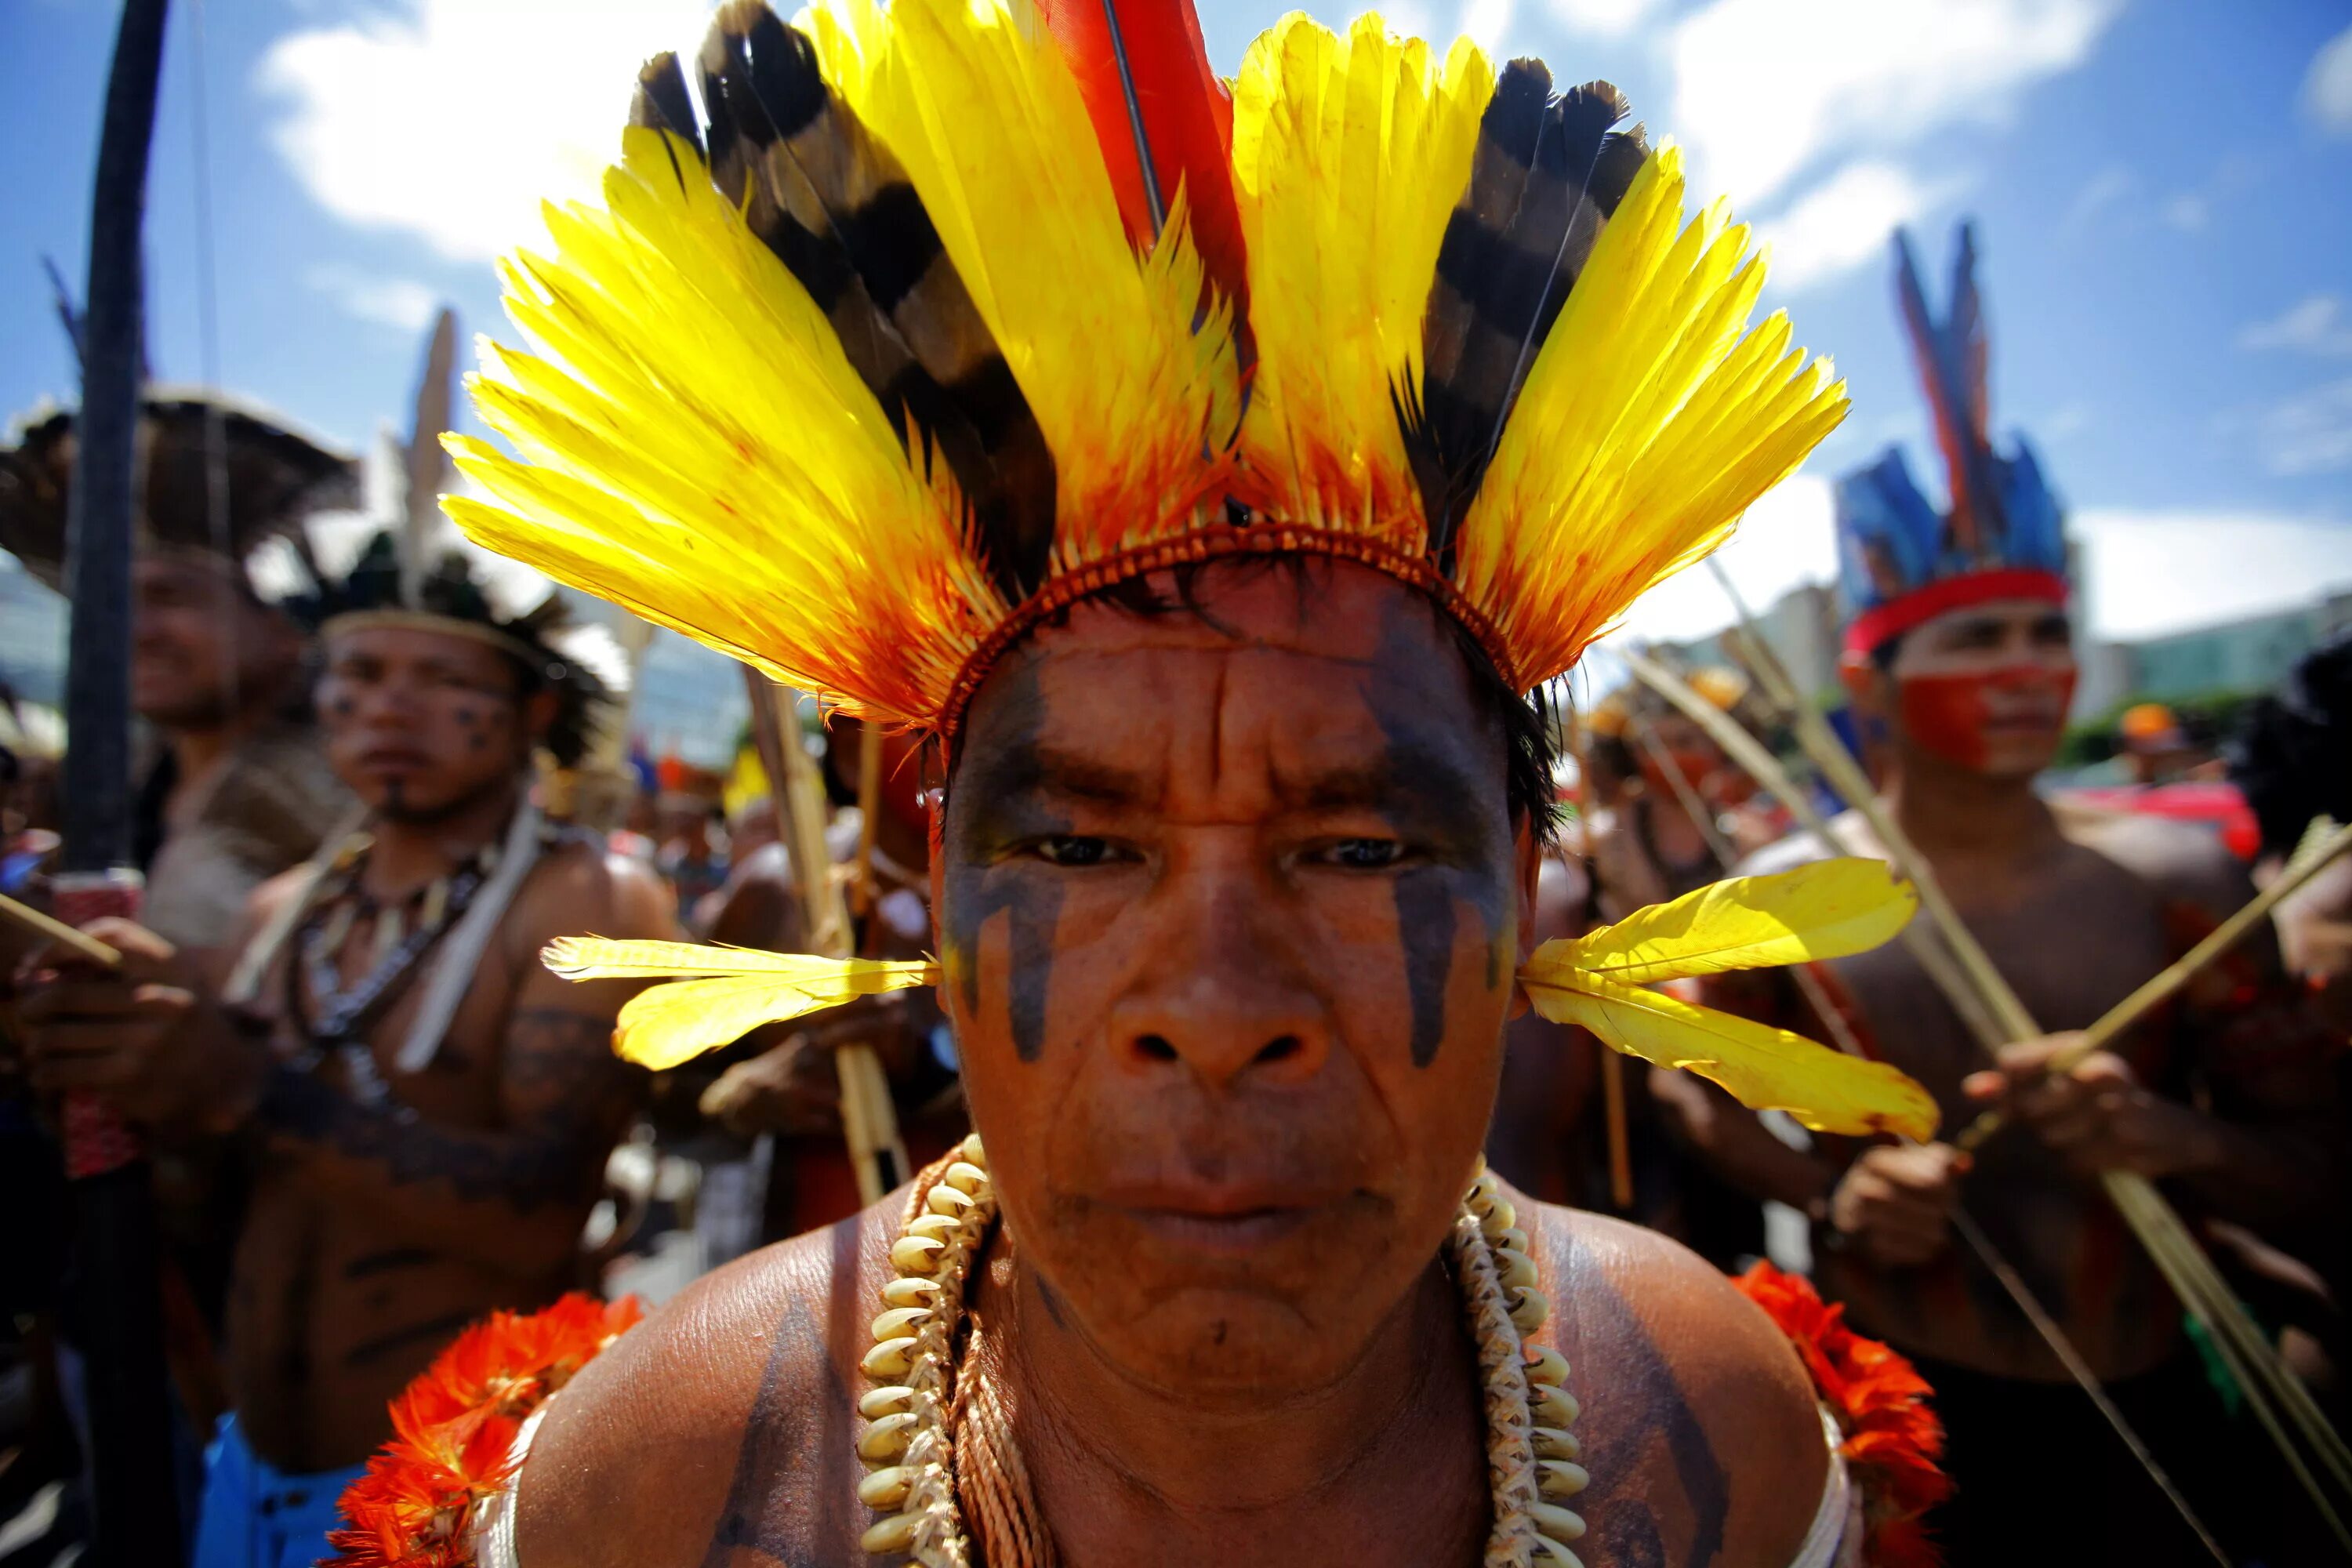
[1519,1201,1830,1568]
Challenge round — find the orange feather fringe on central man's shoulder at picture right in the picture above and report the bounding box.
[1731,1262,1952,1568]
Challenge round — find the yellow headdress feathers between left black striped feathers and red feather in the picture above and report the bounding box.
[800,0,1240,572]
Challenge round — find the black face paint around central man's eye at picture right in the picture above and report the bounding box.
[1364,628,1505,1067]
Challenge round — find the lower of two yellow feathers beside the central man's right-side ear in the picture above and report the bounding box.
[1526,975,1938,1140]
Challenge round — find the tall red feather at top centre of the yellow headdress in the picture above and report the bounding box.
[1037,0,1247,322]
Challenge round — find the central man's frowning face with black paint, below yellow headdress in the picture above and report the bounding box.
[934,574,1536,1399]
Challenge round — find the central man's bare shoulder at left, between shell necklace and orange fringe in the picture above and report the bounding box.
[517,1196,898,1568]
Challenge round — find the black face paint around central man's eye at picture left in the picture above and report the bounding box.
[941,663,1070,1062]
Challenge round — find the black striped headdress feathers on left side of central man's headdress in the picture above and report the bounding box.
[630,0,1054,604]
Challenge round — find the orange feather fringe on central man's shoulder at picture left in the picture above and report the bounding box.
[320,1290,644,1568]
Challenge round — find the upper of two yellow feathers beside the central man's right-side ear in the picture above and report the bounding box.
[1552,855,1919,985]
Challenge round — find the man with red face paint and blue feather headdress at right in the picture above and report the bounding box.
[1661,228,2340,1563]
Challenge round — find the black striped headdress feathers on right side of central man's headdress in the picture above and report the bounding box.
[1397,59,1649,572]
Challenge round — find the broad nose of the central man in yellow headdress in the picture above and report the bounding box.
[1110,851,1331,1088]
